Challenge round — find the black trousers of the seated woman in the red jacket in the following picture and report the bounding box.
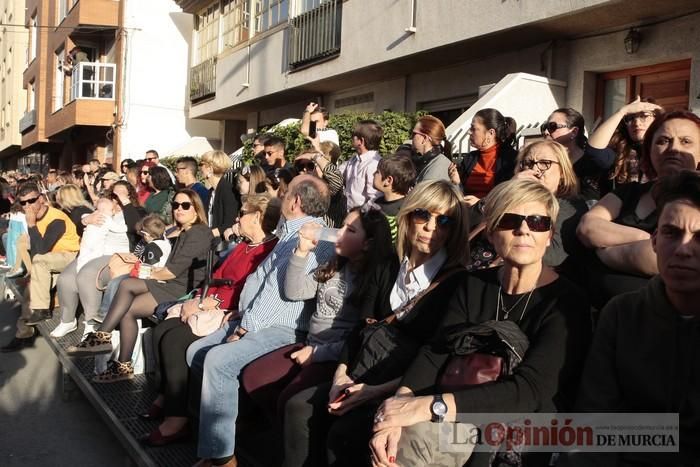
[153,318,199,417]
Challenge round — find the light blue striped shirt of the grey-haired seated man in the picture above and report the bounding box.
[238,216,335,332]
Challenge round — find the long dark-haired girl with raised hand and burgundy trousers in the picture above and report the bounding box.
[242,208,394,421]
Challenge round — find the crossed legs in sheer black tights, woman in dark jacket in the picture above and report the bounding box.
[99,277,158,362]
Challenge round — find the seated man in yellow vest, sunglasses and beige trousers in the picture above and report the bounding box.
[0,182,80,352]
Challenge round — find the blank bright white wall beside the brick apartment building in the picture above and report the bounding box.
[121,0,220,159]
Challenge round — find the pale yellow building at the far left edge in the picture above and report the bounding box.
[0,0,29,168]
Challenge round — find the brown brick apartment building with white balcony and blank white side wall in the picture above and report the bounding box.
[19,0,219,169]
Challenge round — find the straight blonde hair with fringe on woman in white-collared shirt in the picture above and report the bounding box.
[396,180,469,266]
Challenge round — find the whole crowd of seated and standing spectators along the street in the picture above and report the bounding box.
[0,99,700,467]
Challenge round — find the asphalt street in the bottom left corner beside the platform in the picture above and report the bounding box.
[0,301,130,467]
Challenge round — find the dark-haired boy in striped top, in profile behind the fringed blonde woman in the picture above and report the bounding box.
[374,154,416,243]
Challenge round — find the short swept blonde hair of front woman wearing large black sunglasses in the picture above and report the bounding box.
[484,179,559,233]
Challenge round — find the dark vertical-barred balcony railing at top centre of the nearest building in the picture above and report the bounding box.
[289,0,343,70]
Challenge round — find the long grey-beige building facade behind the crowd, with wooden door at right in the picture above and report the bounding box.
[178,0,700,149]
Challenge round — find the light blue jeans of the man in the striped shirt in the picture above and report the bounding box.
[187,321,297,459]
